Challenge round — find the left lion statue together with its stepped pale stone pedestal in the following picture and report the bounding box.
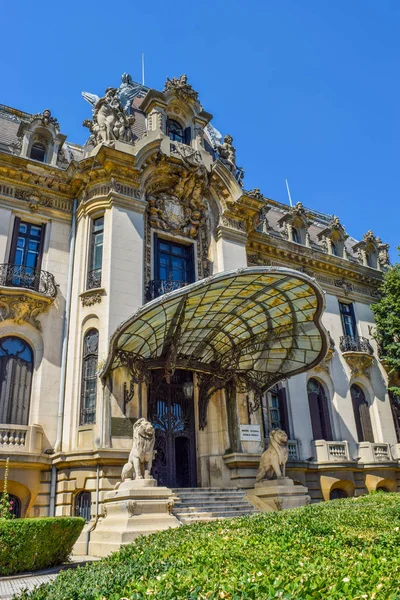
[89,419,180,556]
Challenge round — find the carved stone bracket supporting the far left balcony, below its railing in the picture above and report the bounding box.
[0,293,52,331]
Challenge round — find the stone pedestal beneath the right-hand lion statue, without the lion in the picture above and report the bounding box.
[247,477,310,512]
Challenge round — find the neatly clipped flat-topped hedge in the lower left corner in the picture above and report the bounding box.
[0,517,85,576]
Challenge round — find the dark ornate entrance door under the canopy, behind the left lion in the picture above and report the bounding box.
[148,371,196,487]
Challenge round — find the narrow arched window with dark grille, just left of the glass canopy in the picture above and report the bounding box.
[80,329,99,425]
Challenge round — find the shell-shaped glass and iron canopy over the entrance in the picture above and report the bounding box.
[102,267,328,389]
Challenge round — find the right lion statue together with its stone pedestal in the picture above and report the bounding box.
[247,429,310,512]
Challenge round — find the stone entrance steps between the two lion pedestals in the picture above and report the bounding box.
[172,488,259,524]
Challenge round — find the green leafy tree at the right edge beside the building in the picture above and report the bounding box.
[371,247,400,397]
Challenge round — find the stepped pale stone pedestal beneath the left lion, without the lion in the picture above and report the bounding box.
[89,479,180,556]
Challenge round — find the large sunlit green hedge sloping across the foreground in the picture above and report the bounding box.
[14,494,400,600]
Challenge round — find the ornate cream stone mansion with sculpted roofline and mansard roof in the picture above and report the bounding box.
[0,74,400,517]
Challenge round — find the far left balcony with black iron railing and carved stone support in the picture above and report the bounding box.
[0,264,57,331]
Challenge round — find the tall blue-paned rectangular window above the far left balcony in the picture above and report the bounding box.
[7,217,45,289]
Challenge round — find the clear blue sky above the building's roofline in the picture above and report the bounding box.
[0,0,400,259]
